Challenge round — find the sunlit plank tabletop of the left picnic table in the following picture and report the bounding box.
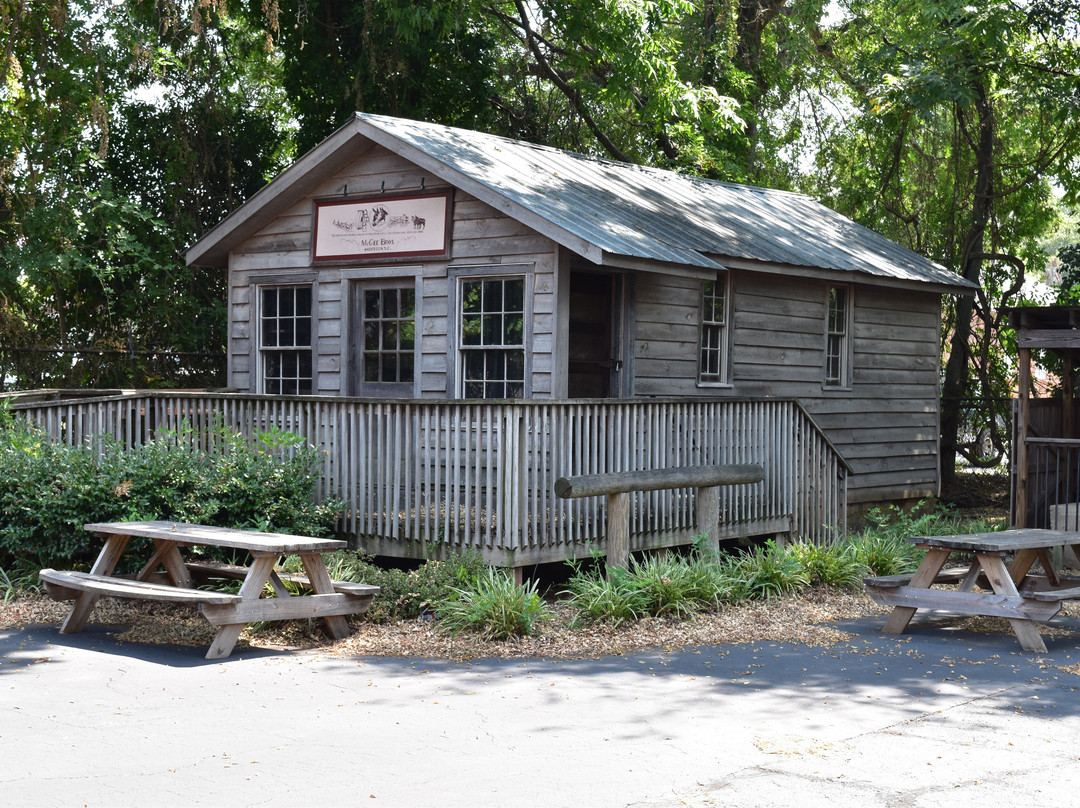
[84,522,349,555]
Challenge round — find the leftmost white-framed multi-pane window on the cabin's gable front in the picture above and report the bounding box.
[259,286,312,395]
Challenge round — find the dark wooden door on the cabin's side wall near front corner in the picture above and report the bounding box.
[567,272,623,399]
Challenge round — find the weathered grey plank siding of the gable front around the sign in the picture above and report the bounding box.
[229,147,558,399]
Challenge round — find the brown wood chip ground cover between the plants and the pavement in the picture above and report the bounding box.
[6,588,1080,661]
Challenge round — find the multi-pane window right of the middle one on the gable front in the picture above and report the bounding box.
[459,278,525,399]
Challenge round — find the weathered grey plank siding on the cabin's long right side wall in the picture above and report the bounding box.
[633,270,941,504]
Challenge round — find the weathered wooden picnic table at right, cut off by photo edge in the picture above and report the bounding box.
[865,529,1080,652]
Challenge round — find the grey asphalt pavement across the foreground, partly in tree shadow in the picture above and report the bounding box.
[0,615,1080,808]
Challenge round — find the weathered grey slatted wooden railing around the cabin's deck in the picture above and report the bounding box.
[13,392,849,566]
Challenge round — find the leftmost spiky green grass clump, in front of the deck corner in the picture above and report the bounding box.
[436,567,551,639]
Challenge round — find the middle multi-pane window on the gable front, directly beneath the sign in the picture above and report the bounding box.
[361,288,416,395]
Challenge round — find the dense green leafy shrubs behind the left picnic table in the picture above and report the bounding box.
[0,413,342,567]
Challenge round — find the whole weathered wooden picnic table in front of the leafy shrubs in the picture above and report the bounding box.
[39,522,379,659]
